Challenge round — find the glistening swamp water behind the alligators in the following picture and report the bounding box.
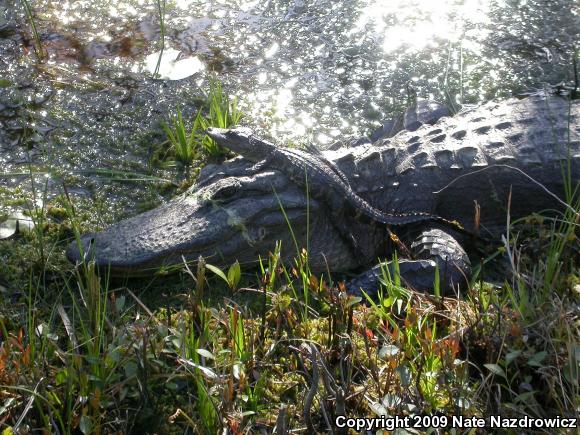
[0,0,580,215]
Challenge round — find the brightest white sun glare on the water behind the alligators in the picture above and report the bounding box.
[233,0,500,143]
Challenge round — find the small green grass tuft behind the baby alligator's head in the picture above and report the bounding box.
[162,79,243,166]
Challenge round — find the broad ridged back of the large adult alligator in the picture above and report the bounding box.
[326,95,580,237]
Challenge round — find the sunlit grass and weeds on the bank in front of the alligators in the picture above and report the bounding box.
[0,182,580,433]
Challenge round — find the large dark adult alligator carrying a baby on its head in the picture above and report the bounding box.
[67,94,580,293]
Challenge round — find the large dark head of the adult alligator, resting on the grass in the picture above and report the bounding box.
[67,158,354,276]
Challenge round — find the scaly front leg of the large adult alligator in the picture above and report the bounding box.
[347,228,471,297]
